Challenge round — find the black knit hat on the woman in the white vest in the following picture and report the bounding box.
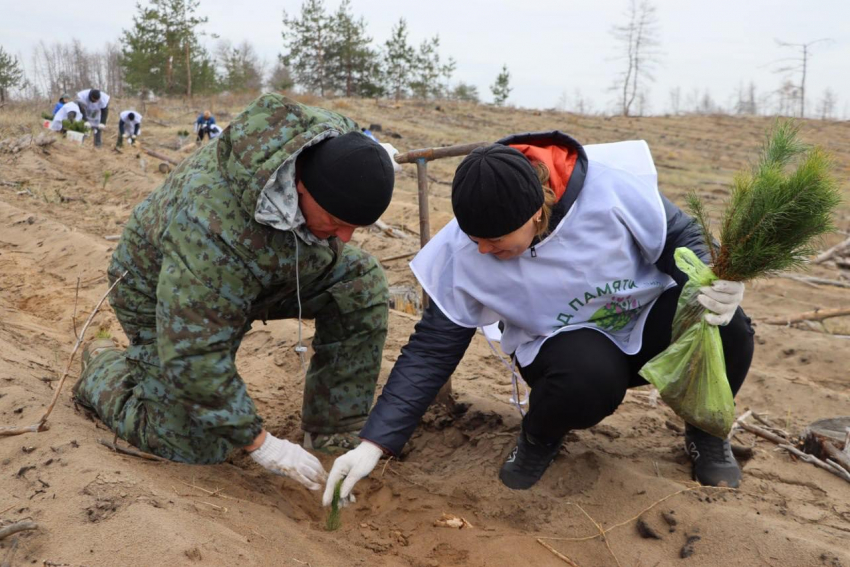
[452,144,543,238]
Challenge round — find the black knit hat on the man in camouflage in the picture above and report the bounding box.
[299,132,395,226]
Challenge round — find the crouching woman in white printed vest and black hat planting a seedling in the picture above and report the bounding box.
[324,132,753,505]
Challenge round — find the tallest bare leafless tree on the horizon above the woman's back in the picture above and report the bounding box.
[611,0,661,116]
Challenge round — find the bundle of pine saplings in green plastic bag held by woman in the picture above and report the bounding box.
[640,122,841,437]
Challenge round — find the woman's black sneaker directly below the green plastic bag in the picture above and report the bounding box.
[685,424,741,488]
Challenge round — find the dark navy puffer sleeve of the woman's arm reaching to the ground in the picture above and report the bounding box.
[360,302,475,455]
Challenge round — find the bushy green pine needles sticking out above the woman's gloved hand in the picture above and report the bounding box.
[688,121,841,281]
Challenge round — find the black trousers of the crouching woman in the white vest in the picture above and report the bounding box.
[520,286,754,442]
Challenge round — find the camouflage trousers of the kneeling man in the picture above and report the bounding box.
[74,246,388,464]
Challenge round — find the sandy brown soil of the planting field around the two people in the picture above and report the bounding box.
[0,98,850,567]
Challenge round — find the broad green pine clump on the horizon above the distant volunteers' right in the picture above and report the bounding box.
[121,0,216,96]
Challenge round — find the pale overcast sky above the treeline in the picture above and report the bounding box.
[6,0,850,118]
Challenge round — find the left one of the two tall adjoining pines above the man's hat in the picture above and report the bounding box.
[281,0,336,96]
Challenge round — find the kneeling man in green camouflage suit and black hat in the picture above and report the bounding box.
[74,94,393,488]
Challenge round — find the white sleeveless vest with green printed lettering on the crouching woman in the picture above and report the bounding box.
[410,140,676,366]
